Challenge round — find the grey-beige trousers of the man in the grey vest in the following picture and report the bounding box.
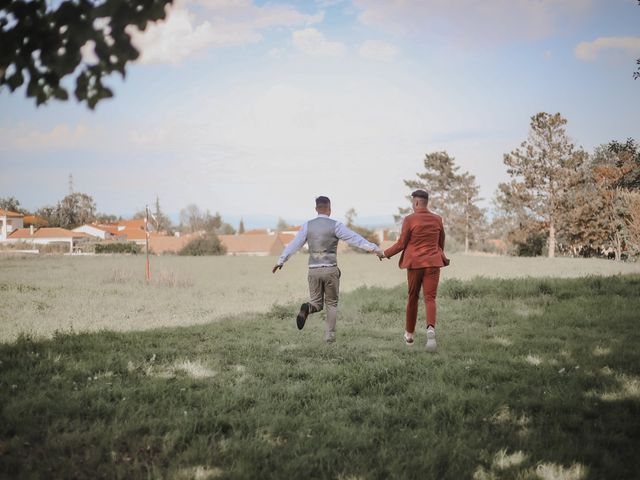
[309,267,340,341]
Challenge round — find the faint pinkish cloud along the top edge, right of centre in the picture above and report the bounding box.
[354,0,593,46]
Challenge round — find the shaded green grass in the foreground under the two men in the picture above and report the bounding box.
[0,275,640,479]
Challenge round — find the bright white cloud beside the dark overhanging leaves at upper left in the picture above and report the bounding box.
[129,0,324,64]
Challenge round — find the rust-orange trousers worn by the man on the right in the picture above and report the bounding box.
[405,267,440,333]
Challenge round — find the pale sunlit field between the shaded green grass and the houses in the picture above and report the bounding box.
[0,254,640,341]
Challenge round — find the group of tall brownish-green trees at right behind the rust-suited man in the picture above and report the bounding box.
[397,112,640,260]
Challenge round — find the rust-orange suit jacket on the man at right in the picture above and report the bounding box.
[384,208,449,268]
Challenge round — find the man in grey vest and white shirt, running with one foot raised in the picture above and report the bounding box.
[272,197,383,342]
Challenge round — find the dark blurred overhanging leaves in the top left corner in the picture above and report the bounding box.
[0,0,172,109]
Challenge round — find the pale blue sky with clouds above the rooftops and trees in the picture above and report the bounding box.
[0,0,640,228]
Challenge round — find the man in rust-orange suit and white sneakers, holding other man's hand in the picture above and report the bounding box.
[384,190,449,351]
